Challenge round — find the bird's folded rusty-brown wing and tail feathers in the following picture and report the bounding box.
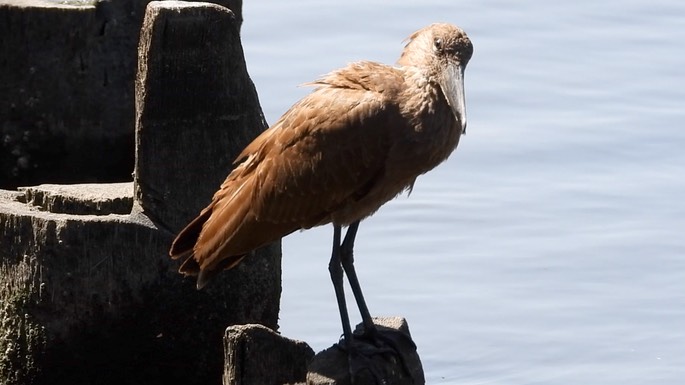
[170,63,401,287]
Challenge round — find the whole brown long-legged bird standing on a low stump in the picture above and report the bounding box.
[170,24,473,378]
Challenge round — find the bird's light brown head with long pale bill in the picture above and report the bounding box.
[397,23,473,133]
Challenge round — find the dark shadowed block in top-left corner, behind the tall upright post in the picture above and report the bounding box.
[0,0,242,188]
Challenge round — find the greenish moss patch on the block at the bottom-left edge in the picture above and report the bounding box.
[0,257,46,385]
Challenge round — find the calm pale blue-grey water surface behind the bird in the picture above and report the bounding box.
[243,0,685,385]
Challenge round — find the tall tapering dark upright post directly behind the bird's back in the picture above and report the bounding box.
[134,1,266,229]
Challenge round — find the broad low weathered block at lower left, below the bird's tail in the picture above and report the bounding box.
[0,195,280,384]
